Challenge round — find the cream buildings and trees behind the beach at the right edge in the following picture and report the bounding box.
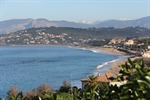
[105,38,150,58]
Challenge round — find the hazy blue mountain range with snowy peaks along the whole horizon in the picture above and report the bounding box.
[0,16,150,34]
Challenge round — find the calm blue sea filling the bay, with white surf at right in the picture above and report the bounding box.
[0,46,127,98]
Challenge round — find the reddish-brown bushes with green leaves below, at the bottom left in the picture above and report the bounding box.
[7,83,53,100]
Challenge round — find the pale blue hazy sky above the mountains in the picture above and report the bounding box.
[0,0,150,21]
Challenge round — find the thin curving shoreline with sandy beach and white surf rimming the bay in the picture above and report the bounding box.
[1,45,135,74]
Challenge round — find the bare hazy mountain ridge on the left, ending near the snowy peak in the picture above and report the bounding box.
[0,18,89,34]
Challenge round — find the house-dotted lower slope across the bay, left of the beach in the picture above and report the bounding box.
[0,29,96,46]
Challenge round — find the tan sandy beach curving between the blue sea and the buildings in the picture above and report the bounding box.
[77,47,136,75]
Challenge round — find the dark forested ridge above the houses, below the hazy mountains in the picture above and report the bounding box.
[18,27,150,39]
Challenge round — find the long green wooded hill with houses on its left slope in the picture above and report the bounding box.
[0,27,150,45]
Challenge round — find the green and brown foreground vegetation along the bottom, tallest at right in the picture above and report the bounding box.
[0,59,150,100]
